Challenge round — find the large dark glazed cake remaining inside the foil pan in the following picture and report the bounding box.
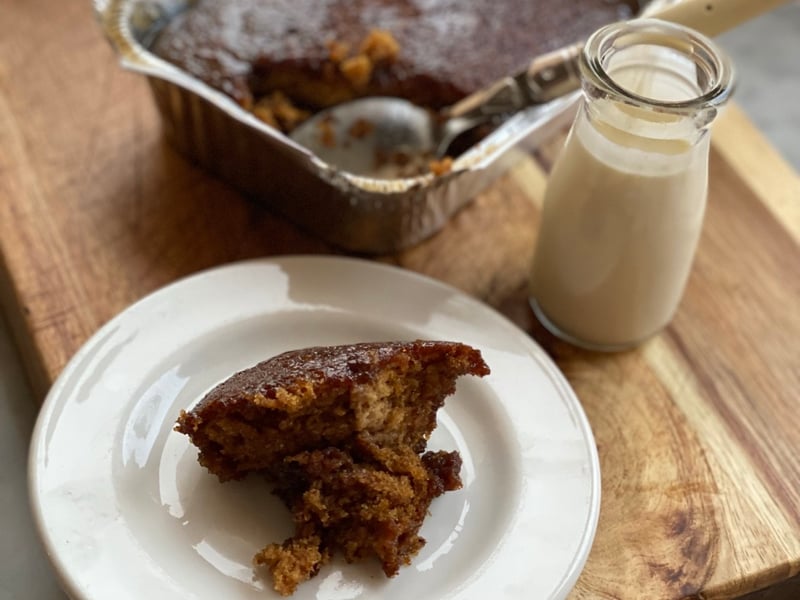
[153,0,639,118]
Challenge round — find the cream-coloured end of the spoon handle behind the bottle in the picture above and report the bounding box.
[644,0,789,37]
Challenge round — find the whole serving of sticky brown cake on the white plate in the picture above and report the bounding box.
[176,341,489,594]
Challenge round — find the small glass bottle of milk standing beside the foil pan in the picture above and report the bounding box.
[530,19,733,350]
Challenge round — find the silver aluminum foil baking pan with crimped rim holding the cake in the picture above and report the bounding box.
[94,0,648,253]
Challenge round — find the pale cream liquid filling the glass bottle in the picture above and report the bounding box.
[531,59,709,348]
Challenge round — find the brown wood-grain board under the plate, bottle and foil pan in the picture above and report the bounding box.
[0,0,800,599]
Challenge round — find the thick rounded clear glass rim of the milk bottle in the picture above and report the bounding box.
[580,18,734,115]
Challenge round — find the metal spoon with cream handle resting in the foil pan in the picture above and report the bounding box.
[290,0,787,178]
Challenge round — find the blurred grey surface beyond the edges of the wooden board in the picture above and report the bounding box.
[0,0,800,600]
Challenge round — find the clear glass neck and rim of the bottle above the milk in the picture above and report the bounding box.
[581,19,733,148]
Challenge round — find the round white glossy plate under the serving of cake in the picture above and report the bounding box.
[30,257,600,600]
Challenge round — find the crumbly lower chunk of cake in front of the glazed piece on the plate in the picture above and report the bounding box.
[254,444,461,594]
